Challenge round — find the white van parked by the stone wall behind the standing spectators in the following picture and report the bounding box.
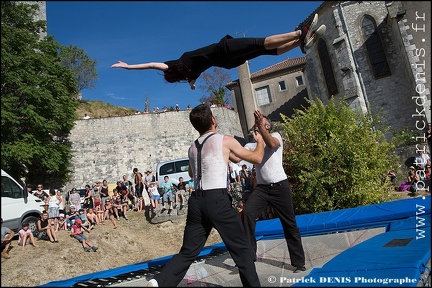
[156,158,191,188]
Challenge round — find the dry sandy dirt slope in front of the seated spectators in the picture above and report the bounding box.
[1,211,222,287]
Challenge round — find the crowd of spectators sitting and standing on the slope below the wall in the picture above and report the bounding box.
[2,169,199,258]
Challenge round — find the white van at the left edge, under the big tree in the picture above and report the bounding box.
[1,169,44,232]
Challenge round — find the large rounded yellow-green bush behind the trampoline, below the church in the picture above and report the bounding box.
[279,99,397,214]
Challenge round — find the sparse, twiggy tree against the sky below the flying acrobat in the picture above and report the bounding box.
[198,67,231,106]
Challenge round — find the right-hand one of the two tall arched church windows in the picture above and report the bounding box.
[362,15,390,78]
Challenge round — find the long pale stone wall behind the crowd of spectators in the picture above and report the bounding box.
[65,108,244,191]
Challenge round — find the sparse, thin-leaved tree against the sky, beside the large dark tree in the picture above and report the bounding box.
[59,45,98,95]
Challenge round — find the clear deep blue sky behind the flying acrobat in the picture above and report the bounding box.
[46,1,322,111]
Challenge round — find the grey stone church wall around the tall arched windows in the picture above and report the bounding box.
[305,1,430,137]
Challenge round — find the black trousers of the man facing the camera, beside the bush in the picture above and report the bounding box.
[243,180,305,267]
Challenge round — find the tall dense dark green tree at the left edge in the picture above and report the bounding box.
[1,1,78,184]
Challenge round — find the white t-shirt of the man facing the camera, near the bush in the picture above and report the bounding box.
[244,132,287,184]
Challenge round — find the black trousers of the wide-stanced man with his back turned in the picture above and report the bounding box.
[154,189,261,287]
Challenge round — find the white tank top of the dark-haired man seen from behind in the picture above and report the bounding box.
[188,133,228,190]
